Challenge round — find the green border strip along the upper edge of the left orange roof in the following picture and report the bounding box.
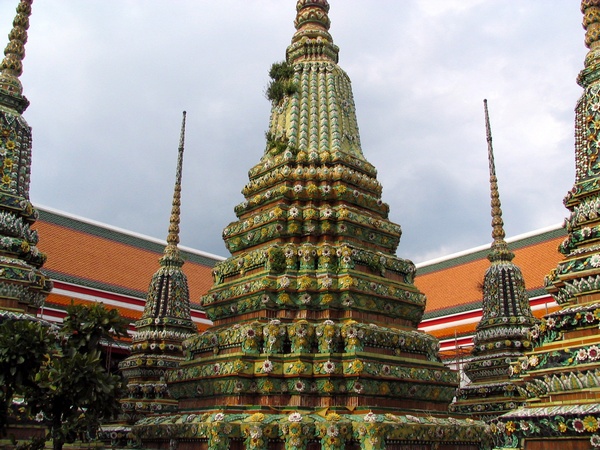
[36,207,221,268]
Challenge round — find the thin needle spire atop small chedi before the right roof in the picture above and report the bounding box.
[483,99,514,261]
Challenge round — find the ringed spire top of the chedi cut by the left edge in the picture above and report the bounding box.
[0,0,33,113]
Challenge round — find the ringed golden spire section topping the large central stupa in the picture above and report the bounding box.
[287,0,339,64]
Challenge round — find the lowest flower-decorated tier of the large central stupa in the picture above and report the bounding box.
[132,409,491,450]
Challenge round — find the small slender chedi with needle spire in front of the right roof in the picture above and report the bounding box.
[450,100,538,419]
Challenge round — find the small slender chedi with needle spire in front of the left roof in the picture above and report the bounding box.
[119,112,196,422]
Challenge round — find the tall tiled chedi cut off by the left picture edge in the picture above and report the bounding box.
[0,0,52,316]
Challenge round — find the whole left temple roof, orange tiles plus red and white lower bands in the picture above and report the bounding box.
[34,207,223,329]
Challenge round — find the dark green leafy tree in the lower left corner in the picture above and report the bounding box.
[0,304,128,449]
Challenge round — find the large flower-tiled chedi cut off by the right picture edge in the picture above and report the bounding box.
[492,0,600,450]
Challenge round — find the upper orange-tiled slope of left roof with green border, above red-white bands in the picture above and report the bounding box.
[34,206,223,302]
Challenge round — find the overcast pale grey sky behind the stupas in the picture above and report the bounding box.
[0,0,586,262]
